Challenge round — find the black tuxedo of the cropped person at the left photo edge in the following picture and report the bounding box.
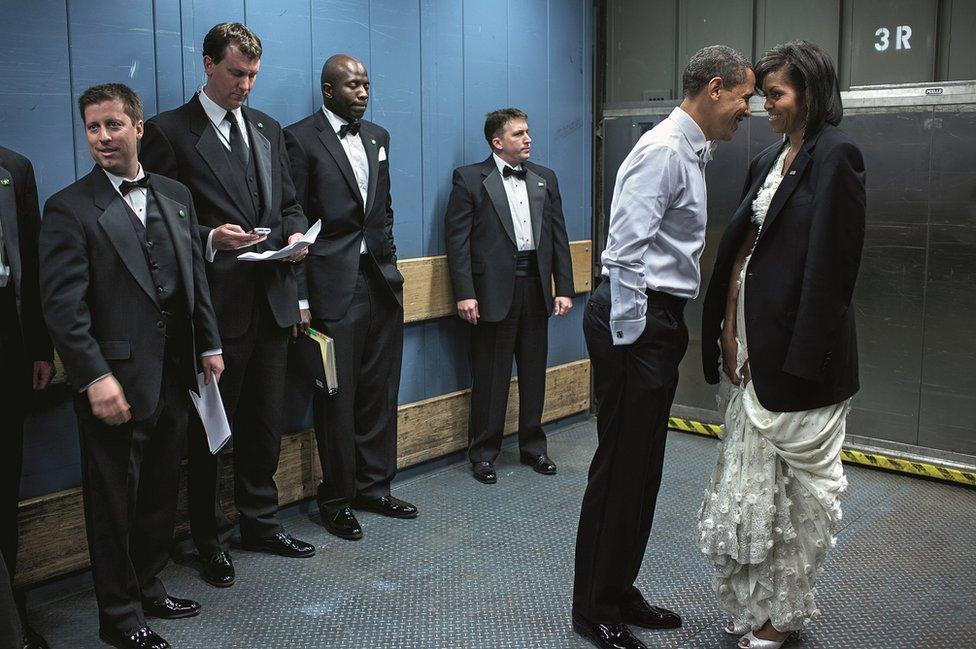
[0,147,53,624]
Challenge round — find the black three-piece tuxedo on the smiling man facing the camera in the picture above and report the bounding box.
[40,167,220,632]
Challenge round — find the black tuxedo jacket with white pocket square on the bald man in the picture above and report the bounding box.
[285,110,403,320]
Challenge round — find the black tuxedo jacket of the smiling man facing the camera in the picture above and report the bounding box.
[40,166,220,420]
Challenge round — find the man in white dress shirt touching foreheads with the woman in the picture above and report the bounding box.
[573,45,755,649]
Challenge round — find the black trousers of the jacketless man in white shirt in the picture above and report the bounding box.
[573,282,688,623]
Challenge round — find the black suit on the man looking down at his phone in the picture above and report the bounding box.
[140,96,307,557]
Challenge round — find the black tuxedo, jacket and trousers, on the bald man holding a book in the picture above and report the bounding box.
[285,110,403,511]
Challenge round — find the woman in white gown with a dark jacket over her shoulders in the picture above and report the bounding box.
[699,41,865,649]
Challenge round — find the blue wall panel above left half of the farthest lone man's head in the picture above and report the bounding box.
[463,0,508,163]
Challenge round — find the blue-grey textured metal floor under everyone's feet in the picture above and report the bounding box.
[26,421,976,649]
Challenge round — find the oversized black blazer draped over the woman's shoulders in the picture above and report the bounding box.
[702,124,865,412]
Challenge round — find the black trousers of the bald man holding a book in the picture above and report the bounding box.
[312,254,403,513]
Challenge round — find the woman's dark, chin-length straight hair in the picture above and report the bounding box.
[756,40,844,135]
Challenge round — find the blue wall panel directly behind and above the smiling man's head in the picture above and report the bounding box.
[68,0,156,176]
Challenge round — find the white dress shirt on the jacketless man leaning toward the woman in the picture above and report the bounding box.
[601,107,711,345]
